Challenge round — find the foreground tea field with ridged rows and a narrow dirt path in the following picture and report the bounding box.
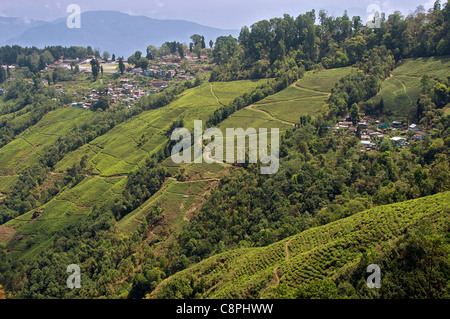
[149,192,450,298]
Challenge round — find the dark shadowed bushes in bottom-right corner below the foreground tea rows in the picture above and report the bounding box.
[332,221,450,299]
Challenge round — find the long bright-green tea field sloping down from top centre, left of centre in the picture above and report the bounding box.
[56,81,266,176]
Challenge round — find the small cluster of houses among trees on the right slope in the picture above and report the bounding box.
[334,117,427,151]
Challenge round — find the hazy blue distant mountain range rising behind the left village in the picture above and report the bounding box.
[0,11,239,57]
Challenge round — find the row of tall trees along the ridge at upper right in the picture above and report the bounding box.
[211,0,450,81]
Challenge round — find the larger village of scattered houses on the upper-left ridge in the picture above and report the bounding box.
[17,54,208,109]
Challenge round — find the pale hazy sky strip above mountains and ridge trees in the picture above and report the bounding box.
[0,0,438,29]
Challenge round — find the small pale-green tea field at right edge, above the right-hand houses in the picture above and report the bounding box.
[371,56,450,120]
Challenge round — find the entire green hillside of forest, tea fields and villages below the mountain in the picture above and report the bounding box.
[0,1,450,298]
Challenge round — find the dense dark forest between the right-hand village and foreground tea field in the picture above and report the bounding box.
[179,115,450,261]
